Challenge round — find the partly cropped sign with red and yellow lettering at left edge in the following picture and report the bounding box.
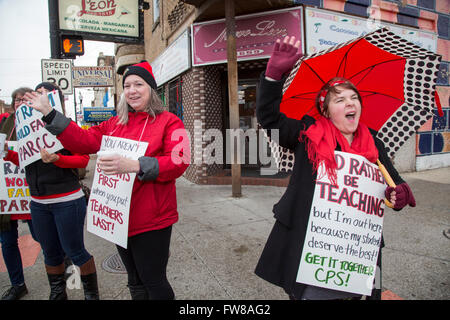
[0,141,31,214]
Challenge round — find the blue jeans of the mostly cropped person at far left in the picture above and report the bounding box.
[0,220,37,286]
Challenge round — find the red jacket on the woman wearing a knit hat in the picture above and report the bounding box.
[52,111,190,237]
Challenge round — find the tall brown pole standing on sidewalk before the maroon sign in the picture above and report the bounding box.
[225,0,242,197]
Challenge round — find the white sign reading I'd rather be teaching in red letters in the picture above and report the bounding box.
[297,151,386,295]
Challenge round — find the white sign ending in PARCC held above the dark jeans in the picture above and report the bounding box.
[16,91,63,168]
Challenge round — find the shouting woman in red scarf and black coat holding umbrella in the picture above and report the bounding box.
[255,37,415,300]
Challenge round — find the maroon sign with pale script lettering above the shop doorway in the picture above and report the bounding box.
[192,7,303,66]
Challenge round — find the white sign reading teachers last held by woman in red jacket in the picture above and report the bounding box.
[87,136,148,248]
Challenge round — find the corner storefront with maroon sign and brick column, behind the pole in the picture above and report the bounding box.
[152,7,303,185]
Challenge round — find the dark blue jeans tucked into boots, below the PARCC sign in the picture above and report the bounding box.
[30,197,91,266]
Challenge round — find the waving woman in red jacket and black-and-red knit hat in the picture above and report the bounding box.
[26,61,190,300]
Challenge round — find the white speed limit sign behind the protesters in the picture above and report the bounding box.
[41,59,73,95]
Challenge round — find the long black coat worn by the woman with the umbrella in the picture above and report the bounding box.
[255,74,404,297]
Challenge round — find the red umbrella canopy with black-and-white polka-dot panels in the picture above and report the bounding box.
[271,28,441,171]
